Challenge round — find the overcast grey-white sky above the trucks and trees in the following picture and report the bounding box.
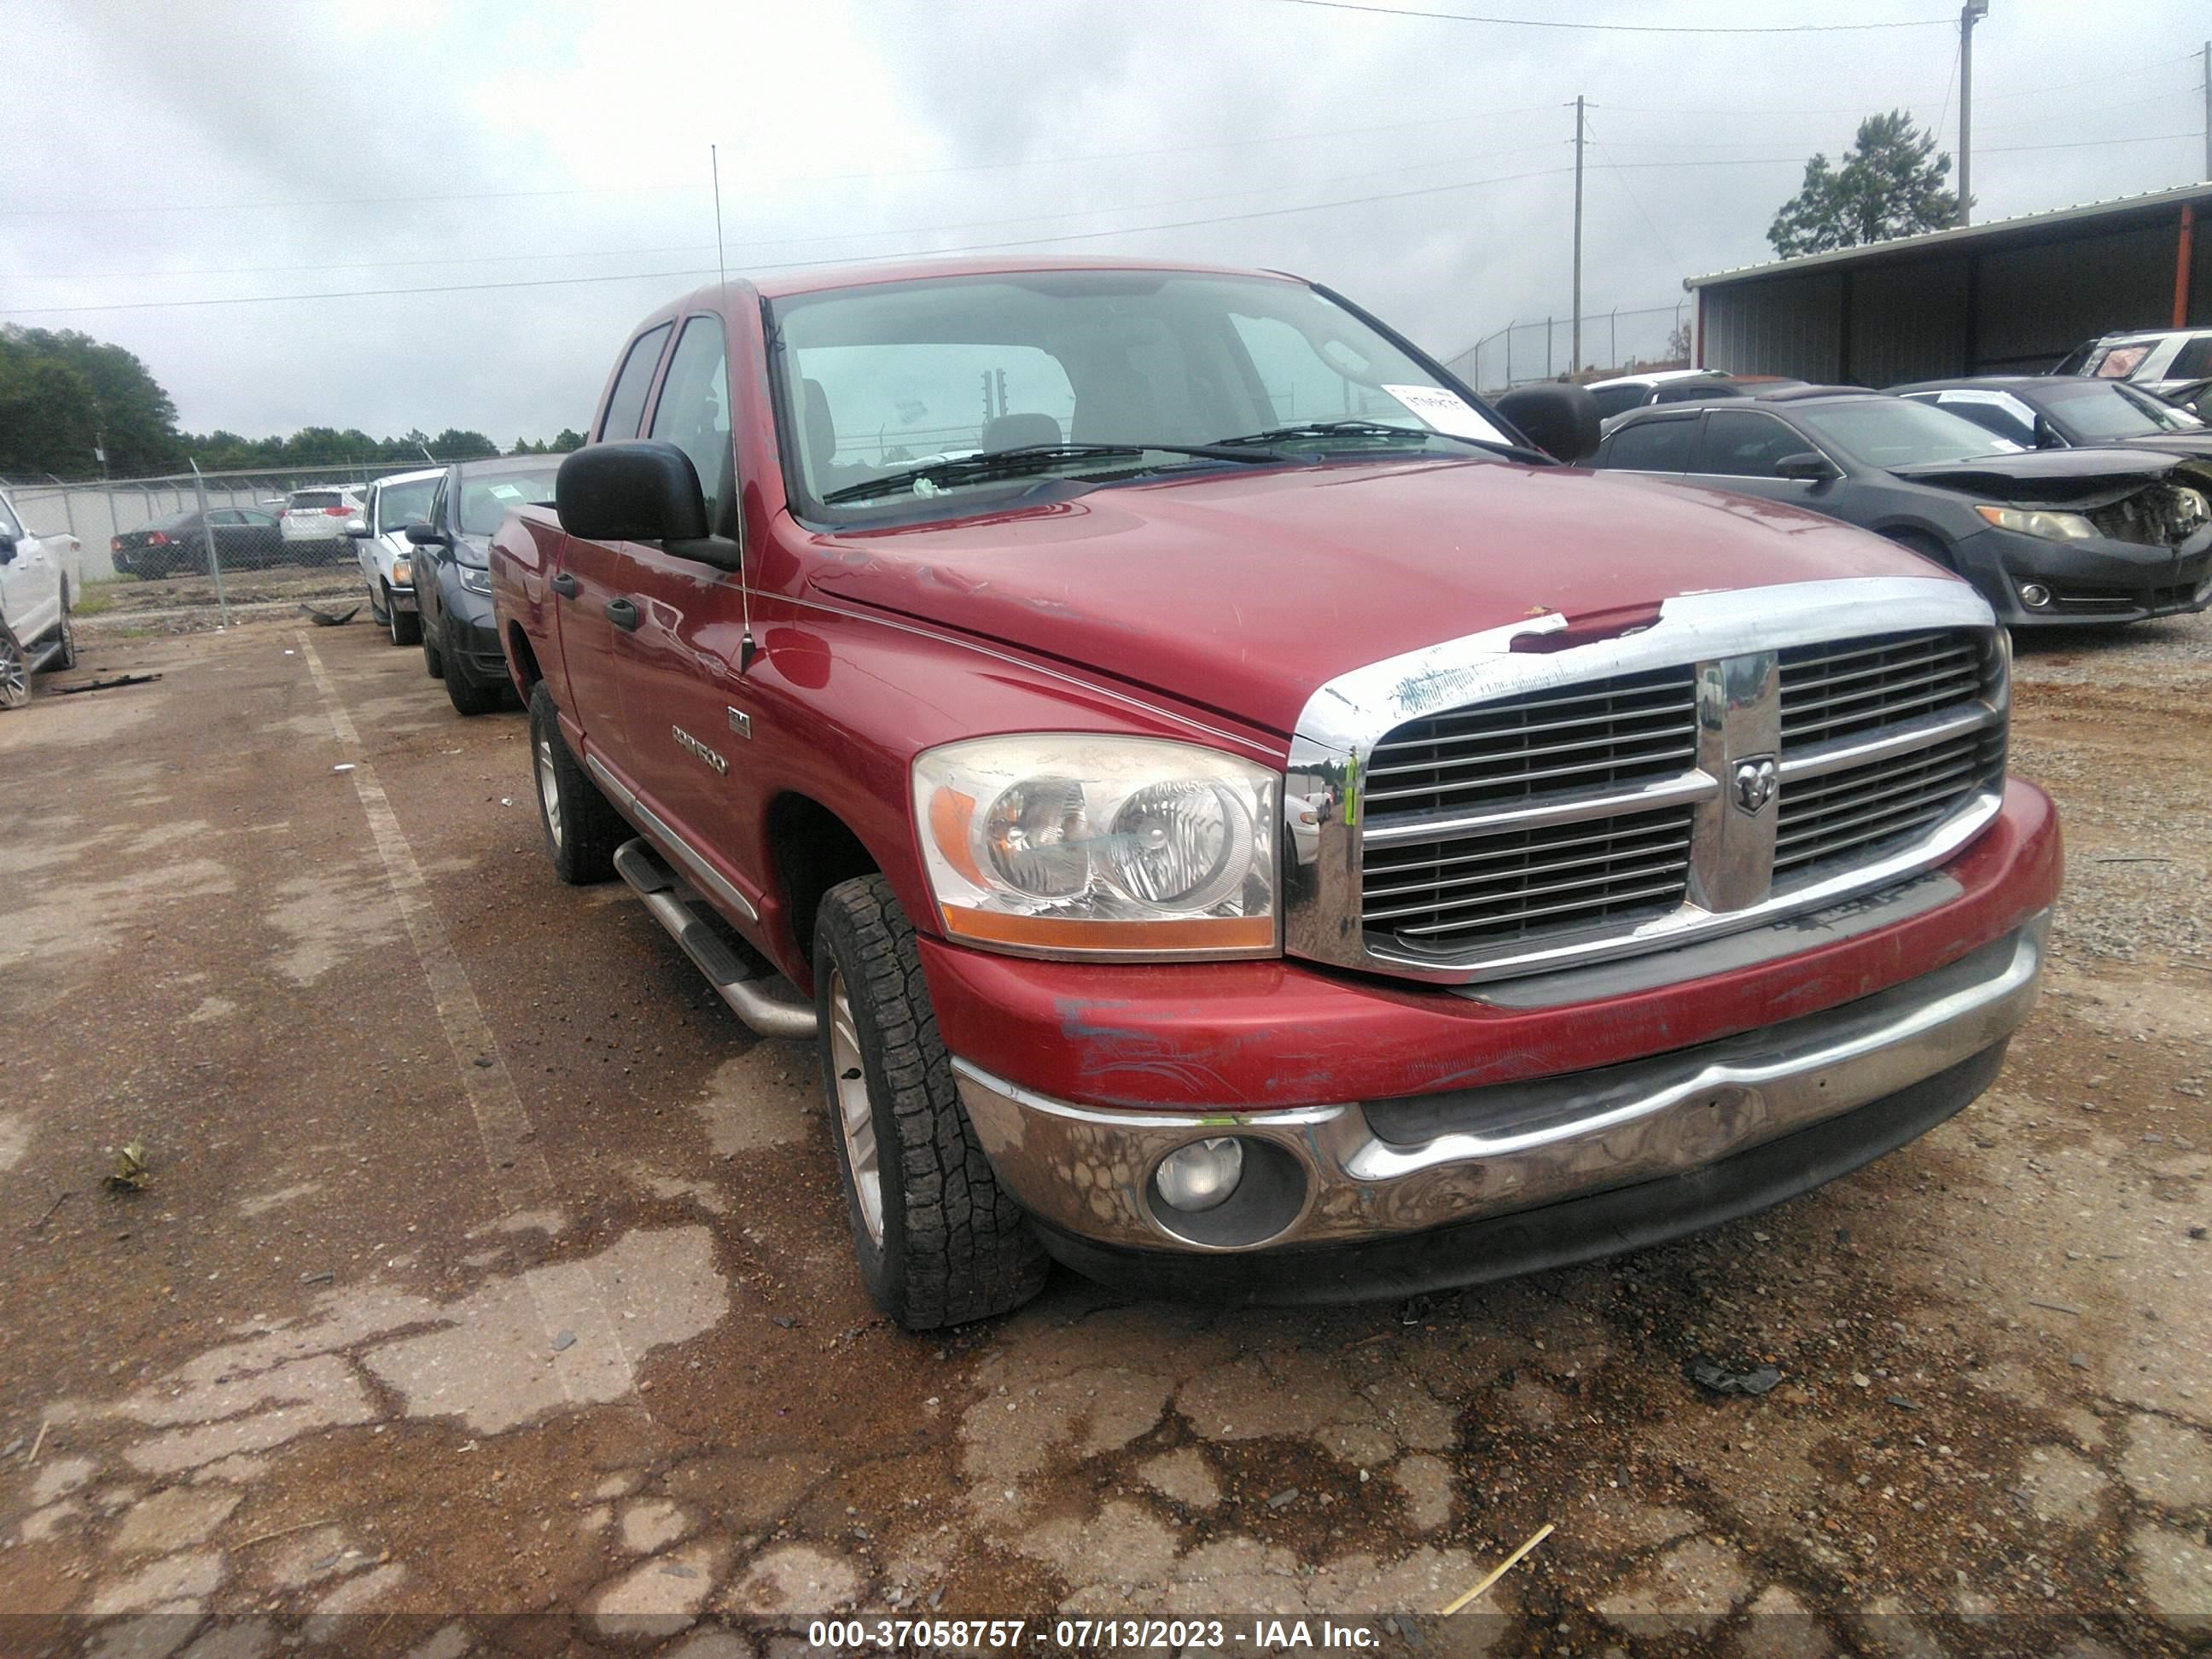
[0,0,2208,455]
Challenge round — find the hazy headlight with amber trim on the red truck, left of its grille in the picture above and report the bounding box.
[913,732,1278,958]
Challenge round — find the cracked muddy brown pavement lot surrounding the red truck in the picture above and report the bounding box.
[0,620,2212,1655]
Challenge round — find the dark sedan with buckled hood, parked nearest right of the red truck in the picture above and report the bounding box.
[1592,387,2212,626]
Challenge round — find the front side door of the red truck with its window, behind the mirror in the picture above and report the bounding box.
[615,314,761,920]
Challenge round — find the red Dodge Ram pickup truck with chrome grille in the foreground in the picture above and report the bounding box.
[491,259,2059,1327]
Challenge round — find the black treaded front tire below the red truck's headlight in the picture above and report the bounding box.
[814,876,1051,1331]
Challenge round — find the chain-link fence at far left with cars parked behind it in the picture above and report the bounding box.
[0,460,438,582]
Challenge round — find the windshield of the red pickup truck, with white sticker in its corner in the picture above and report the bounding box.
[774,270,1509,518]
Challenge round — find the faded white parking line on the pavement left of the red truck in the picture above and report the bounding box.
[299,628,653,1423]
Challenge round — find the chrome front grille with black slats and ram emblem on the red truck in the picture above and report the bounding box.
[1285,578,2009,982]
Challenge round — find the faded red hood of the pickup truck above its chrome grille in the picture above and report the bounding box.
[810,460,1938,735]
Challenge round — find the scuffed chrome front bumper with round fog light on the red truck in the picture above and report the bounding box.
[953,911,2051,1254]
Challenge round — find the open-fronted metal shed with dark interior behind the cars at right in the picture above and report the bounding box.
[1684,183,2212,387]
